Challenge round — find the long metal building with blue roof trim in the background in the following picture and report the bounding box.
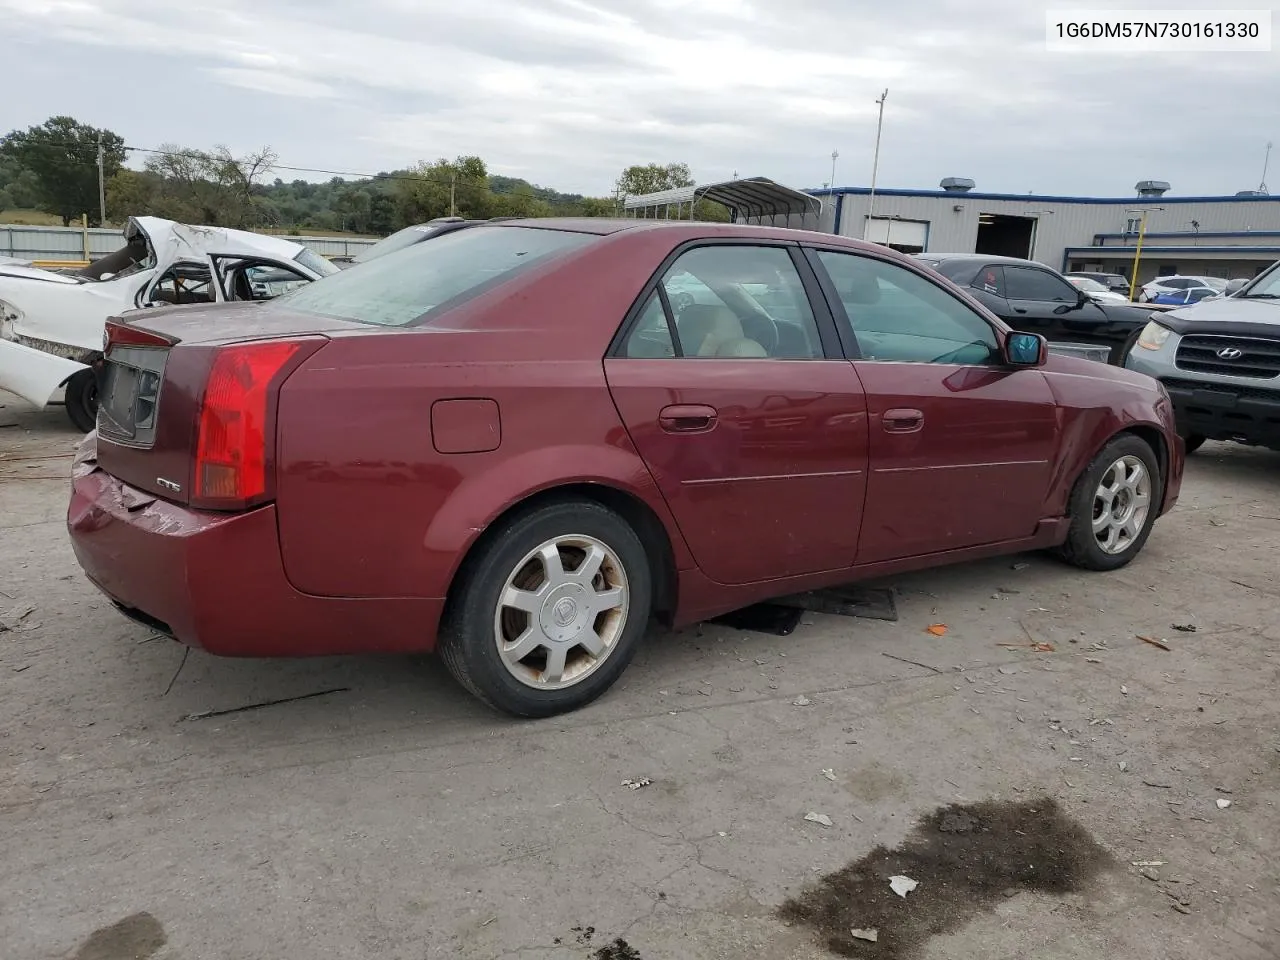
[805,177,1280,283]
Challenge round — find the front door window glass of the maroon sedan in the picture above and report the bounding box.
[818,250,1000,364]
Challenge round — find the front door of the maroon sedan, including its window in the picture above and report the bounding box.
[813,250,1059,563]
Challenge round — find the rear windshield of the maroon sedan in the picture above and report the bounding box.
[275,227,598,326]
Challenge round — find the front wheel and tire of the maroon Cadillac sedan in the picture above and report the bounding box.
[1057,435,1165,570]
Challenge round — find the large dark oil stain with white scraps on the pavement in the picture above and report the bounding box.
[780,797,1114,960]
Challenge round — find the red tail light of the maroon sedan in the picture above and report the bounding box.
[195,338,323,508]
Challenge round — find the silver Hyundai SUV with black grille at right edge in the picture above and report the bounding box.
[1124,262,1280,453]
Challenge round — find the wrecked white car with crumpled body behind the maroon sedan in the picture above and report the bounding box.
[0,216,338,433]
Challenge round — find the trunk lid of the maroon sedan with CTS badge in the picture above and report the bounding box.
[97,303,376,506]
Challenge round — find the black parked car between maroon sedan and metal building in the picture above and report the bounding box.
[915,253,1151,365]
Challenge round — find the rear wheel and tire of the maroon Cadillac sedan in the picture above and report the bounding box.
[439,500,653,717]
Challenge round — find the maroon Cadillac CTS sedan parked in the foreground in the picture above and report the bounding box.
[68,220,1184,717]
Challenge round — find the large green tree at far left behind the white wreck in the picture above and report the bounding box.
[0,116,125,225]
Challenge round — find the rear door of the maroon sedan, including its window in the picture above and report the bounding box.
[605,242,867,584]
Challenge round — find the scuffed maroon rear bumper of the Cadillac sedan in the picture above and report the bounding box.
[67,434,444,657]
